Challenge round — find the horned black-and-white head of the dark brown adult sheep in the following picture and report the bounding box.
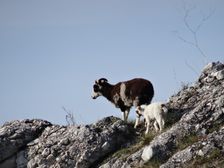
[92,78,108,99]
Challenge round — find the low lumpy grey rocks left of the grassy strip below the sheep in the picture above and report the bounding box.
[0,117,135,168]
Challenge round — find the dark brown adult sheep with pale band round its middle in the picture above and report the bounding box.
[92,78,154,127]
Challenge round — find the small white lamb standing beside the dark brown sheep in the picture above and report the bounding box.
[136,103,168,134]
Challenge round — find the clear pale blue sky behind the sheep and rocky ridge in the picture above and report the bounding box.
[0,0,224,125]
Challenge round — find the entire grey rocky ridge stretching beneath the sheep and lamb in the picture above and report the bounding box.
[0,62,224,168]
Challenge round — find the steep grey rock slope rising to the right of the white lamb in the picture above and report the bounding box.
[101,62,224,168]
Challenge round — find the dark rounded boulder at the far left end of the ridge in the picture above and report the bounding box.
[0,120,51,167]
